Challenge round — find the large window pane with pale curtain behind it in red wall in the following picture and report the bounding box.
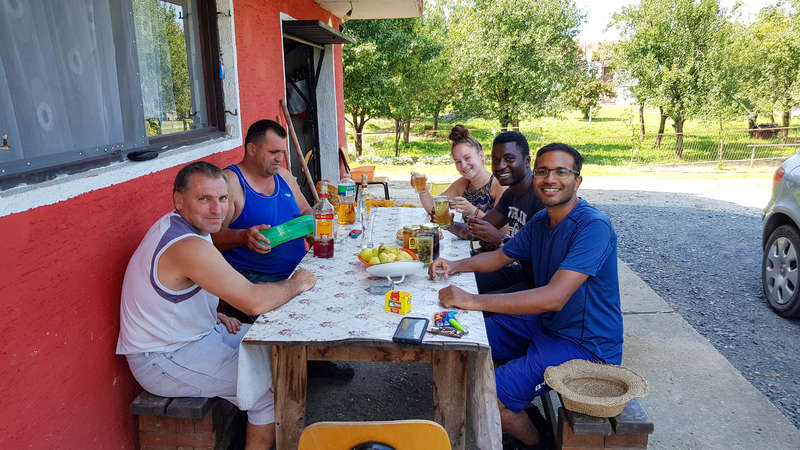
[0,0,208,180]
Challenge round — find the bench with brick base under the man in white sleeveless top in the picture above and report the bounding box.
[130,391,244,450]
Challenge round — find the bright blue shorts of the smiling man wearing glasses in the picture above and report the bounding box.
[485,314,597,412]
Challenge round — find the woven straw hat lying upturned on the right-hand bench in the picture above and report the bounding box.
[544,359,647,417]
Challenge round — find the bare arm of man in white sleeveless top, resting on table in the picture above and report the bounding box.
[159,238,316,315]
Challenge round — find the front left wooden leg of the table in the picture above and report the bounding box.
[272,345,307,449]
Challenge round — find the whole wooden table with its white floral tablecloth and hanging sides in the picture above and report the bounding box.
[238,208,501,449]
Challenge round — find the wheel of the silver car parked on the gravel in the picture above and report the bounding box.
[761,225,800,317]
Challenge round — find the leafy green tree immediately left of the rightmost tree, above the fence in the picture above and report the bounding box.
[612,0,726,158]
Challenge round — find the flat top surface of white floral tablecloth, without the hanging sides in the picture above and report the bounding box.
[244,208,489,348]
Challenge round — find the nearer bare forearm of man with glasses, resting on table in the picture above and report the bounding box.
[439,269,589,314]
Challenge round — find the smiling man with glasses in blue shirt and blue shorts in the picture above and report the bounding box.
[430,143,622,448]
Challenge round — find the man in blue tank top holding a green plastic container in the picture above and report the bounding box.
[211,120,354,378]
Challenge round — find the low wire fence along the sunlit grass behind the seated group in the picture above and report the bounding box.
[350,127,800,166]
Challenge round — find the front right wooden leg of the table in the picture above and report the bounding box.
[433,350,467,450]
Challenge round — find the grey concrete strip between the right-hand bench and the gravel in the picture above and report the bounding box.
[620,261,800,449]
